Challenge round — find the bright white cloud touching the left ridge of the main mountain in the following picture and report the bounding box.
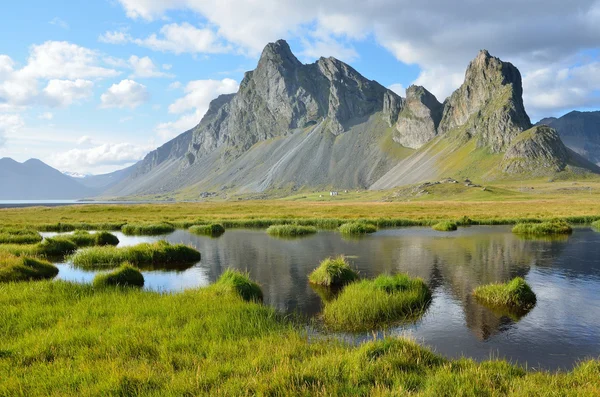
[156,79,239,140]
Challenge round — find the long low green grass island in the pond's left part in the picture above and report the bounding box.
[71,241,200,269]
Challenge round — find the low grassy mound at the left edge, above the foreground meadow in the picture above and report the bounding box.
[0,252,58,283]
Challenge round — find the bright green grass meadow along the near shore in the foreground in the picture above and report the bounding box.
[0,281,600,397]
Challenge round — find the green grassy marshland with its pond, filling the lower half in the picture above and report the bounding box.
[0,206,600,395]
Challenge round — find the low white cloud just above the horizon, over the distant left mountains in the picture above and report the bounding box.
[49,143,153,172]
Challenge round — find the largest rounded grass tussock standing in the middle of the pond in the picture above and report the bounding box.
[323,274,431,332]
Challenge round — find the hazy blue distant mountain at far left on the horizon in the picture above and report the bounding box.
[0,157,98,200]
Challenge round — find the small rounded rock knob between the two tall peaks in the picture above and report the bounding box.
[393,85,443,149]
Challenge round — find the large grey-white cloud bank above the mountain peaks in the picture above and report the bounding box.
[118,0,600,112]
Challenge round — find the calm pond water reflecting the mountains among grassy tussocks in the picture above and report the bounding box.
[48,226,600,370]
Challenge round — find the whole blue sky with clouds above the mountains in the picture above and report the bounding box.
[0,0,600,173]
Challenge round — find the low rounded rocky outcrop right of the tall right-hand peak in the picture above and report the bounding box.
[500,126,569,174]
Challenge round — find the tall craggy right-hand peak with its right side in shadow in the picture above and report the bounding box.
[438,50,531,153]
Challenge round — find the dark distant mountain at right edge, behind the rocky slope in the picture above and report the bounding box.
[536,111,600,164]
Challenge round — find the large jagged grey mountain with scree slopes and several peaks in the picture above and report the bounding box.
[104,40,600,198]
